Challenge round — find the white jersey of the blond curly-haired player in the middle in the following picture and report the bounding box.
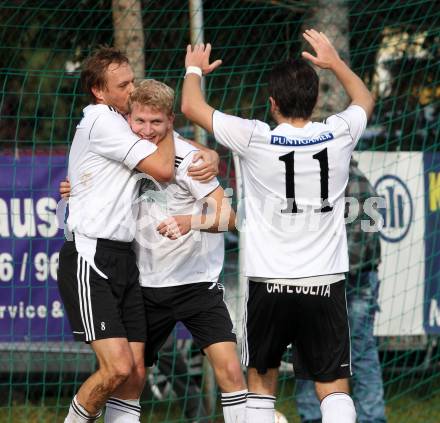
[134,133,224,288]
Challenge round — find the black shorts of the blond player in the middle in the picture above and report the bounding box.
[142,282,237,367]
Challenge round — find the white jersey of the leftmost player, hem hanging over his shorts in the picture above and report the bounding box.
[67,104,157,265]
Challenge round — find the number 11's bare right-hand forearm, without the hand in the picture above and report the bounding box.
[331,59,374,117]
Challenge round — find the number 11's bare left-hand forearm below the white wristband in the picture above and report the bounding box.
[181,73,214,133]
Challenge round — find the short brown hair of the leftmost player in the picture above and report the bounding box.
[81,47,128,103]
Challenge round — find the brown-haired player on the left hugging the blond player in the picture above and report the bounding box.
[58,48,217,423]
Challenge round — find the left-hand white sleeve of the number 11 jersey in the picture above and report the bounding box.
[212,110,257,155]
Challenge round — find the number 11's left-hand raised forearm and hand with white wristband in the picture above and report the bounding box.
[182,44,221,134]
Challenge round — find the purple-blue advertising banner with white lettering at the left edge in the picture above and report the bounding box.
[0,153,71,342]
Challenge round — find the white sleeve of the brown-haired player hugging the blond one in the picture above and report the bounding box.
[90,113,157,169]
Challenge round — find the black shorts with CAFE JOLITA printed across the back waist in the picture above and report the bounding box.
[242,281,351,382]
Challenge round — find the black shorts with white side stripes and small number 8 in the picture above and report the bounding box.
[58,239,146,342]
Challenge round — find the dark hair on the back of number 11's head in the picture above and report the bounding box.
[269,59,319,119]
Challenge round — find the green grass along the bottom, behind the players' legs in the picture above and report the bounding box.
[0,377,440,423]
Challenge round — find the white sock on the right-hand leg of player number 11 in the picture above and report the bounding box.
[321,392,356,423]
